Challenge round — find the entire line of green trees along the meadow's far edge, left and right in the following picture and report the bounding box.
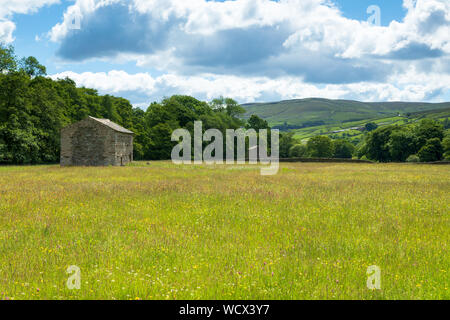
[0,45,450,164]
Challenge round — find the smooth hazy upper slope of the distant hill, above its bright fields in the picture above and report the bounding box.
[243,98,450,129]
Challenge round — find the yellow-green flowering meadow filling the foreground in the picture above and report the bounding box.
[0,162,450,300]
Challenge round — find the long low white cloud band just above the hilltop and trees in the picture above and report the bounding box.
[51,67,450,106]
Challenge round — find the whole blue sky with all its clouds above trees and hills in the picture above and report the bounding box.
[0,0,450,107]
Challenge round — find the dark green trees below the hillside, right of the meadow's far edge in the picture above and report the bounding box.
[280,119,450,162]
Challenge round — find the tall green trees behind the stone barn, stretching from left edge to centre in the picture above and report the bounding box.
[0,45,268,164]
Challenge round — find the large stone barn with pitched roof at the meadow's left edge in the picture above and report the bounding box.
[61,117,134,166]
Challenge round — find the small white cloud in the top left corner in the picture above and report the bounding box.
[0,0,59,43]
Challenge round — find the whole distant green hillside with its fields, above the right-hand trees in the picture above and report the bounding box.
[243,98,450,144]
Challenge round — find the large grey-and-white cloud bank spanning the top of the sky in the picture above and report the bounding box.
[50,0,450,58]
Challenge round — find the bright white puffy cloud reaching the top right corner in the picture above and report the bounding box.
[285,0,450,58]
